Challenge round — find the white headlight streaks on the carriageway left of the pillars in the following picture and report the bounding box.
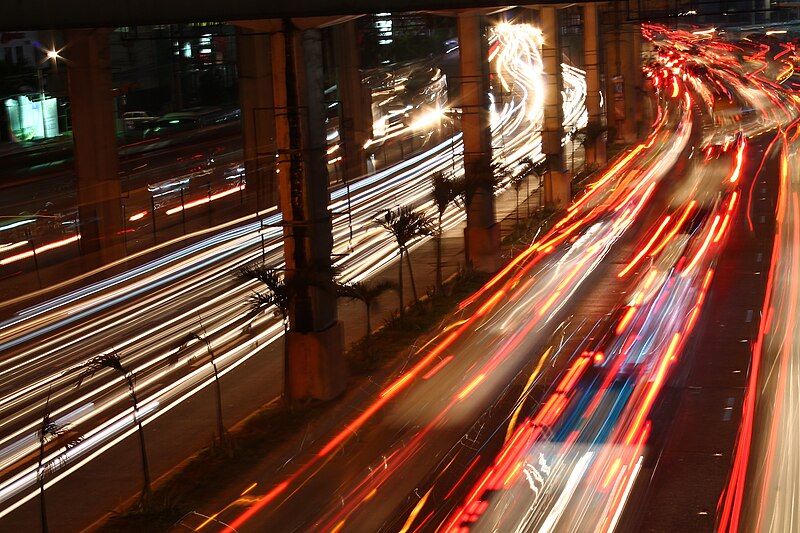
[0,22,585,516]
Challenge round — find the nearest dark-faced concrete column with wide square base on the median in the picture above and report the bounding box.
[271,20,347,400]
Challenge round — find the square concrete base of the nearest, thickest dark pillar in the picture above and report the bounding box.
[285,321,347,400]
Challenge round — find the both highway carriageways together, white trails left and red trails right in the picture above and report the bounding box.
[0,19,800,532]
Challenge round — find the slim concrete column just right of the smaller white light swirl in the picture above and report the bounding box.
[583,2,606,165]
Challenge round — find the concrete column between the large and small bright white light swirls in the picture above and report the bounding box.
[540,7,572,209]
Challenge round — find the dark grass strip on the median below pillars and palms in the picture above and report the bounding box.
[99,274,488,533]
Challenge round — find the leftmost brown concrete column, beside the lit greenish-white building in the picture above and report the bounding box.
[64,29,125,270]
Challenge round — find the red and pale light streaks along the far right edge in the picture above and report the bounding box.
[717,122,800,532]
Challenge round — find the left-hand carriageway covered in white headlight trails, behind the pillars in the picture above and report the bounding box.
[0,21,585,528]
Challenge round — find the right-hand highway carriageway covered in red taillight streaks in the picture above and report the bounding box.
[178,22,798,531]
